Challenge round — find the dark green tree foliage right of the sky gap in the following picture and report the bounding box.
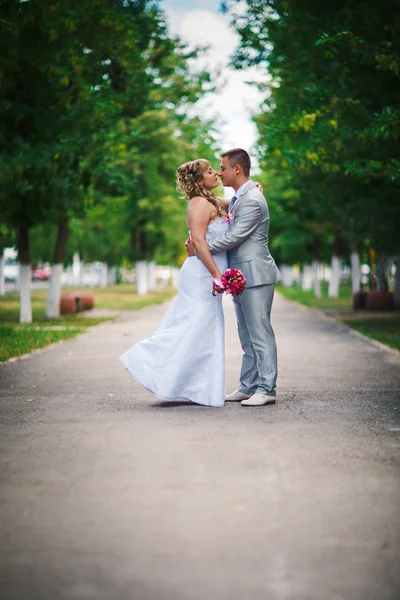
[225,0,400,262]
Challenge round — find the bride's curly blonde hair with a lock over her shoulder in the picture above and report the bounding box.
[176,158,226,217]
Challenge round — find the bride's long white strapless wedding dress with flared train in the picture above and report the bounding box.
[120,217,228,406]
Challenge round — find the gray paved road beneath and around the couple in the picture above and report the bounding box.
[0,298,400,600]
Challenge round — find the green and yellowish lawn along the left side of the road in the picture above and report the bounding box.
[0,284,176,362]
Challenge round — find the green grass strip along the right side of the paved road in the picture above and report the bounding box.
[277,282,400,350]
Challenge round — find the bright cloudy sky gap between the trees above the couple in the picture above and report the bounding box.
[161,0,268,158]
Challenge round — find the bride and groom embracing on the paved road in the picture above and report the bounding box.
[121,148,281,406]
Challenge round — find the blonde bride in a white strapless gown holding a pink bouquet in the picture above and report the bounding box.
[120,158,229,406]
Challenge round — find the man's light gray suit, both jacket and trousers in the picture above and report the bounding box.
[207,181,282,396]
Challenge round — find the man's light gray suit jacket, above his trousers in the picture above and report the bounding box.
[207,181,282,288]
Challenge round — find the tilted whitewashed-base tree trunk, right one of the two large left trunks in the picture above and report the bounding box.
[46,215,69,319]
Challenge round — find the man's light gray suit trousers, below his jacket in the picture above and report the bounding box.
[233,283,278,396]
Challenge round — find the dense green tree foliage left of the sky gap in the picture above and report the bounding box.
[0,0,219,263]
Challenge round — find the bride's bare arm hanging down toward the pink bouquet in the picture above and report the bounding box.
[188,196,221,279]
